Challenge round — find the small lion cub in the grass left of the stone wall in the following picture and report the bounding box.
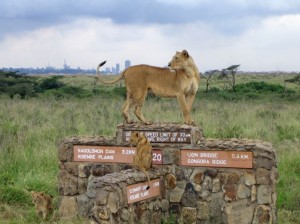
[31,191,53,220]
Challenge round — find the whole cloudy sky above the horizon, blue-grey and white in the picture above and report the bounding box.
[0,0,300,72]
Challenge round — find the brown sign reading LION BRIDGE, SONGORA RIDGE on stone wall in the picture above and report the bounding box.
[181,149,253,168]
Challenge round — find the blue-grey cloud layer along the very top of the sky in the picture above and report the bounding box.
[0,0,300,39]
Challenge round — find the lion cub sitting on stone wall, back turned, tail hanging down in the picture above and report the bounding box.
[130,132,152,190]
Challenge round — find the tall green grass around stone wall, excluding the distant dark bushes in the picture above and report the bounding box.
[0,78,300,223]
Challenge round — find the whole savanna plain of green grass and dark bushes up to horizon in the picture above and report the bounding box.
[0,74,300,224]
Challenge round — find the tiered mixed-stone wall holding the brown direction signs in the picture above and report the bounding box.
[58,124,278,224]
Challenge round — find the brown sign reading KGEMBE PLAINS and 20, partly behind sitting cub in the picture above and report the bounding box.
[73,145,163,165]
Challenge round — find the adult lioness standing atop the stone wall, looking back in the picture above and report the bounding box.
[97,50,200,125]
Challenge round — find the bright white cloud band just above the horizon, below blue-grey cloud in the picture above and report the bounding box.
[0,12,300,72]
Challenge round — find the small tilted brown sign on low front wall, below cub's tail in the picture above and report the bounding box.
[127,179,160,204]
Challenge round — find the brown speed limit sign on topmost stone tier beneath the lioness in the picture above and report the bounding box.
[123,130,191,143]
